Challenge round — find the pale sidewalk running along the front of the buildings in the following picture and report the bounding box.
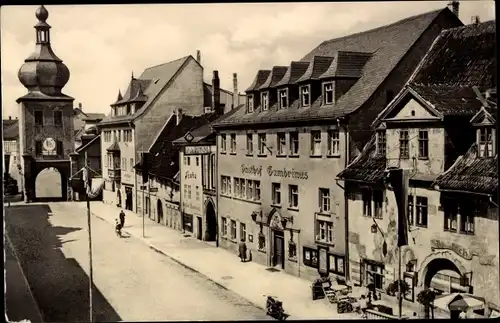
[69,202,410,319]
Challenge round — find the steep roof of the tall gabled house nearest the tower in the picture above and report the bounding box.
[100,55,191,125]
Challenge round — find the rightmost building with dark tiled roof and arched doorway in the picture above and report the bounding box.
[339,22,499,309]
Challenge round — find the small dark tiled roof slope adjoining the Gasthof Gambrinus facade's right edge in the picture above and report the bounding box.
[337,135,386,183]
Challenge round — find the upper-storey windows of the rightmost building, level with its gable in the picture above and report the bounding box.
[376,128,495,159]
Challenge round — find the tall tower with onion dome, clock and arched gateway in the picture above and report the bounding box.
[17,5,74,202]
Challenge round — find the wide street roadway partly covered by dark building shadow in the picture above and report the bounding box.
[5,203,270,322]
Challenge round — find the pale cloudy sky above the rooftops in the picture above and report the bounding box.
[1,1,495,119]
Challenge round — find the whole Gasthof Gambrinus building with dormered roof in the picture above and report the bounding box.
[214,9,461,279]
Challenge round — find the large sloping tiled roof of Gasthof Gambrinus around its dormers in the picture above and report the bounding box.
[215,8,460,127]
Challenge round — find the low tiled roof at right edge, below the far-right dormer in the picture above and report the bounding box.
[434,143,498,194]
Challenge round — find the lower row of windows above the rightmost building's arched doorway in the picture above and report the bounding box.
[358,189,475,234]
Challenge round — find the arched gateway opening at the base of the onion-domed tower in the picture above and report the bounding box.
[35,167,66,201]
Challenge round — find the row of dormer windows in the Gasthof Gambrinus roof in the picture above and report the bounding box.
[247,81,394,113]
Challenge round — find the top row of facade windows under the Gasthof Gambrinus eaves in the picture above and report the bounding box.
[220,129,340,157]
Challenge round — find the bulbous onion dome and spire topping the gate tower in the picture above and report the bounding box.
[18,5,70,96]
